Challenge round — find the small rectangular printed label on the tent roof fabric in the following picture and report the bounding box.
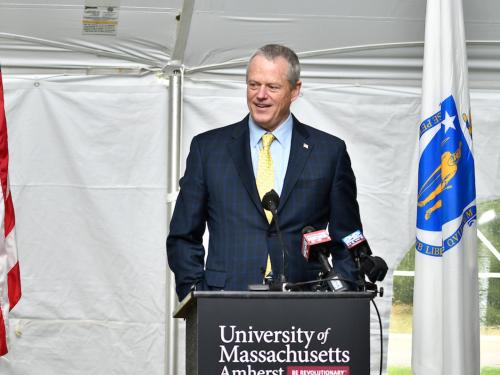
[82,0,120,35]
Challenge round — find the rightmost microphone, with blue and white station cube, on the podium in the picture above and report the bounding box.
[342,230,388,283]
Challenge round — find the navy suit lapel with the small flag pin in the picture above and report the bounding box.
[278,116,313,212]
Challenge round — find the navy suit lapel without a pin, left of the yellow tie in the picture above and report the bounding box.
[228,116,266,218]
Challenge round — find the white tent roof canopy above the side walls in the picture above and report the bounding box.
[0,0,500,82]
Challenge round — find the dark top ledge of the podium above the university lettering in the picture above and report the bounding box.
[173,291,376,318]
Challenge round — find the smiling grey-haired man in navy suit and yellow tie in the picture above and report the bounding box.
[167,45,361,299]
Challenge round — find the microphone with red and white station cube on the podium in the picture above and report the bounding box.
[302,226,350,292]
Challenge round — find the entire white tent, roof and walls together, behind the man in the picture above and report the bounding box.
[0,0,500,375]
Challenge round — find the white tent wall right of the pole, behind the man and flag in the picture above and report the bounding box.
[182,79,500,374]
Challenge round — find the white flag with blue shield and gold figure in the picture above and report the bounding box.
[412,0,480,375]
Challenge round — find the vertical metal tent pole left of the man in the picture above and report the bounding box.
[165,69,183,375]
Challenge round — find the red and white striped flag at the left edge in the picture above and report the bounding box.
[0,70,21,356]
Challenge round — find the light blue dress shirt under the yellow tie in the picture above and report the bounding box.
[248,114,293,196]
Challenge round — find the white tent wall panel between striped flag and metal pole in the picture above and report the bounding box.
[0,76,168,375]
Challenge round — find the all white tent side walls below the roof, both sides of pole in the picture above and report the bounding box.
[0,71,500,375]
